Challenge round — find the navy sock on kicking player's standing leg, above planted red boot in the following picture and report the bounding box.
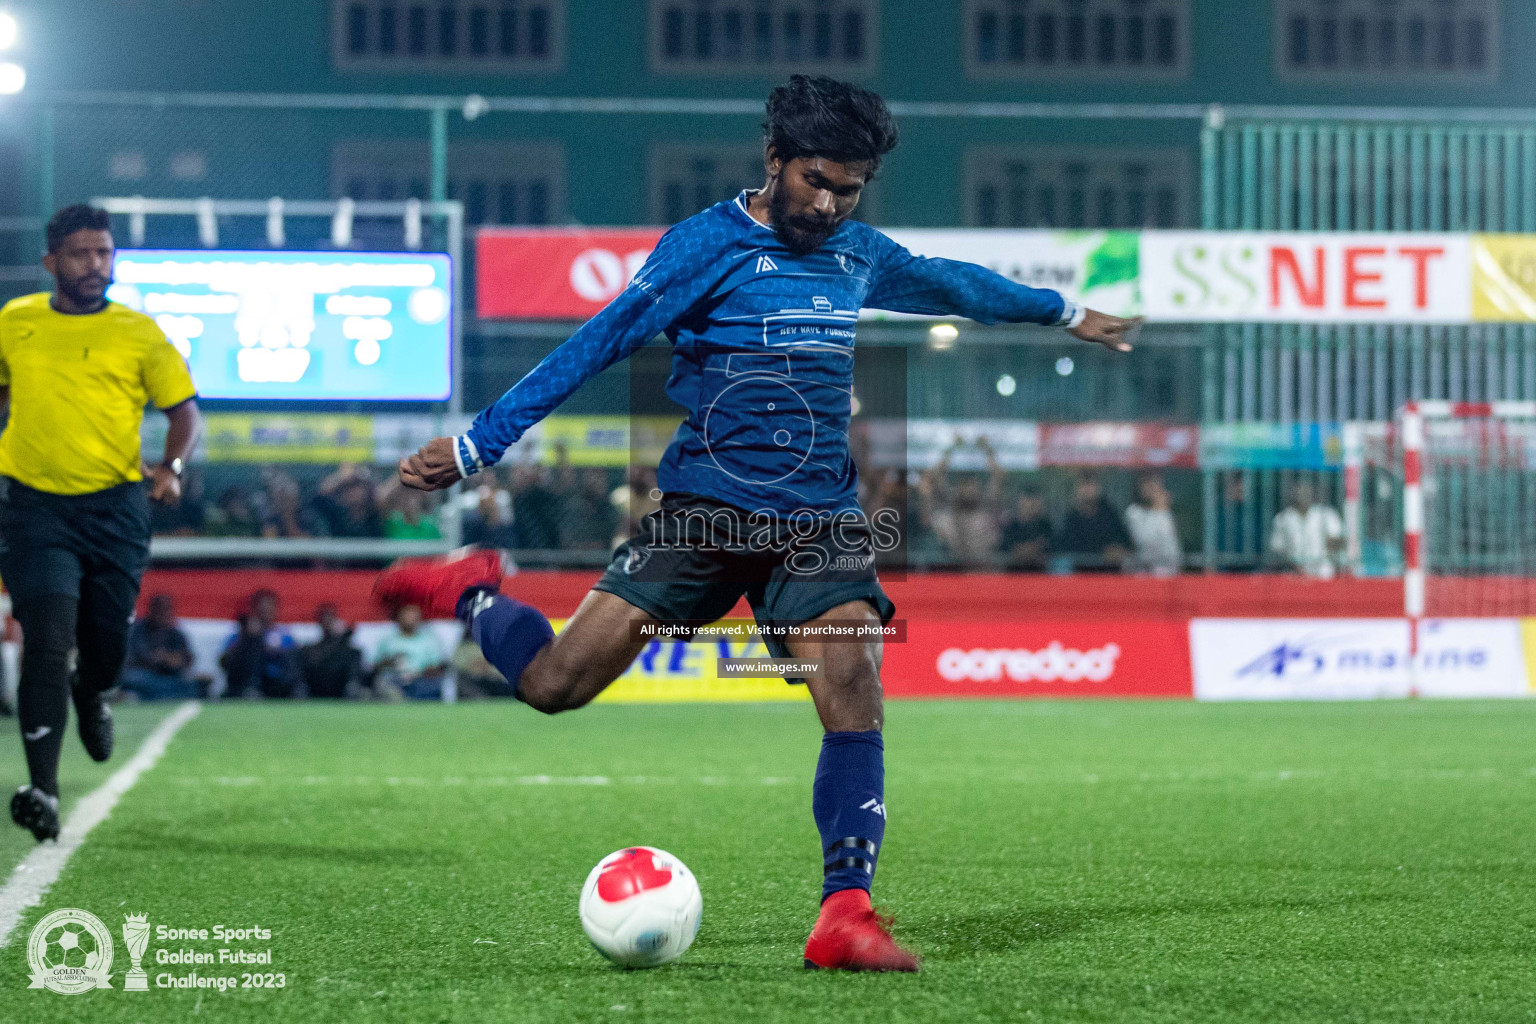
[811,732,885,900]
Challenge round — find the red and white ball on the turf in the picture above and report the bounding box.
[581,846,703,967]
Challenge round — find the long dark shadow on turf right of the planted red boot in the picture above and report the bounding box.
[897,894,1402,960]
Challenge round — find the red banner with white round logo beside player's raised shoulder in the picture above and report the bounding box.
[475,227,662,319]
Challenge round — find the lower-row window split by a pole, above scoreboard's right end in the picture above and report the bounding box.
[330,140,565,226]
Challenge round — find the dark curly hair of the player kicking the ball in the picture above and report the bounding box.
[763,75,897,178]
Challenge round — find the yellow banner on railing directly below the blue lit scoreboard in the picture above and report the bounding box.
[204,413,373,462]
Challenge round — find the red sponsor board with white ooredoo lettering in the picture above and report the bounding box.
[880,619,1193,697]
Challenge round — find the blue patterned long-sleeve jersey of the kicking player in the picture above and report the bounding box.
[459,192,1077,514]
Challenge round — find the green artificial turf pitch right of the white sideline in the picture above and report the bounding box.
[0,702,1536,1024]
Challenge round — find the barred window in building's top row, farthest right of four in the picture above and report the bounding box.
[1275,0,1499,81]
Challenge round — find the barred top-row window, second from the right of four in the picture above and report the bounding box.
[962,0,1189,78]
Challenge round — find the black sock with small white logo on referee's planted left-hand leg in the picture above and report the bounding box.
[15,594,80,797]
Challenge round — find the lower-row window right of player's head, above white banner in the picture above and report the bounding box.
[965,147,1195,229]
